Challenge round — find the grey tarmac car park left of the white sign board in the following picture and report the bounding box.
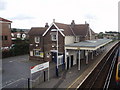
[0,55,38,88]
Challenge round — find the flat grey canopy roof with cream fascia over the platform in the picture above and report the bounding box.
[65,39,112,50]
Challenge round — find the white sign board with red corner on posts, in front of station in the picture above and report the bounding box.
[31,62,49,74]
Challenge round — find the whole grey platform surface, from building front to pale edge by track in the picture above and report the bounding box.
[35,42,117,88]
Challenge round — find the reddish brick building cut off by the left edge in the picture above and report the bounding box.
[0,17,12,50]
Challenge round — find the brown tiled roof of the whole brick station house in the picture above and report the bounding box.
[29,22,95,36]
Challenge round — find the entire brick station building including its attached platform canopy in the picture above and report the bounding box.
[29,20,111,70]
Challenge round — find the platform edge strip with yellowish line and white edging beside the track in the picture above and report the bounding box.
[67,42,118,89]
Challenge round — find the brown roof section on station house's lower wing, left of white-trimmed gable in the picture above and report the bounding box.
[28,27,47,35]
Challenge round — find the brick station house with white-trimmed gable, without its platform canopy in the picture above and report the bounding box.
[28,20,95,65]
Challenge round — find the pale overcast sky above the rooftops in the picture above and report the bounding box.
[0,0,119,33]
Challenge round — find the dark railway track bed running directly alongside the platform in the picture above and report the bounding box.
[78,43,119,89]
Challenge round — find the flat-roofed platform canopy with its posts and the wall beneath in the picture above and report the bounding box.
[65,39,112,70]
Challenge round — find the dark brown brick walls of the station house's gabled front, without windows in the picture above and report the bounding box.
[29,26,64,61]
